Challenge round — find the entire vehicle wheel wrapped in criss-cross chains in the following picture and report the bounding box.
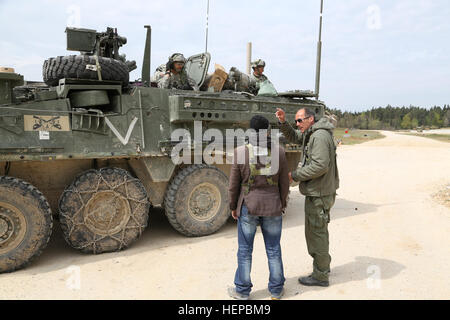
[59,168,150,254]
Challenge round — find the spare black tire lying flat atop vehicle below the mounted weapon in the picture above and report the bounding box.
[42,54,130,86]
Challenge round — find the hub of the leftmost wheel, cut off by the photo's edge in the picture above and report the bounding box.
[0,202,27,254]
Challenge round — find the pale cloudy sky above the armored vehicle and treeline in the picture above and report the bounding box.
[0,0,450,110]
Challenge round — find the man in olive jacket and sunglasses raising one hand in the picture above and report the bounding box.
[276,108,339,287]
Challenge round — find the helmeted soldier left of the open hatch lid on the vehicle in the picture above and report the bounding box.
[158,53,199,91]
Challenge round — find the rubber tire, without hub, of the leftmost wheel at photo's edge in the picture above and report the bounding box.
[0,176,53,273]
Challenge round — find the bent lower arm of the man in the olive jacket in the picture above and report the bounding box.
[292,135,330,181]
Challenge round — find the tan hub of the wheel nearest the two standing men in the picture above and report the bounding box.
[188,182,221,220]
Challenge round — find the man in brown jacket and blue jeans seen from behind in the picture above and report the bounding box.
[228,115,289,300]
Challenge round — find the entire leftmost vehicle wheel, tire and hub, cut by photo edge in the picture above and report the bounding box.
[0,177,53,272]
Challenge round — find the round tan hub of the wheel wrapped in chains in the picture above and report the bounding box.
[84,191,131,235]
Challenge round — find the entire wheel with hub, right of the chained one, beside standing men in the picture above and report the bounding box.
[164,164,230,236]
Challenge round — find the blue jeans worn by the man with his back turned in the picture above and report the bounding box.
[234,204,285,295]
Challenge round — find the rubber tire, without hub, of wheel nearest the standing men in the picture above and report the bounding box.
[164,164,231,237]
